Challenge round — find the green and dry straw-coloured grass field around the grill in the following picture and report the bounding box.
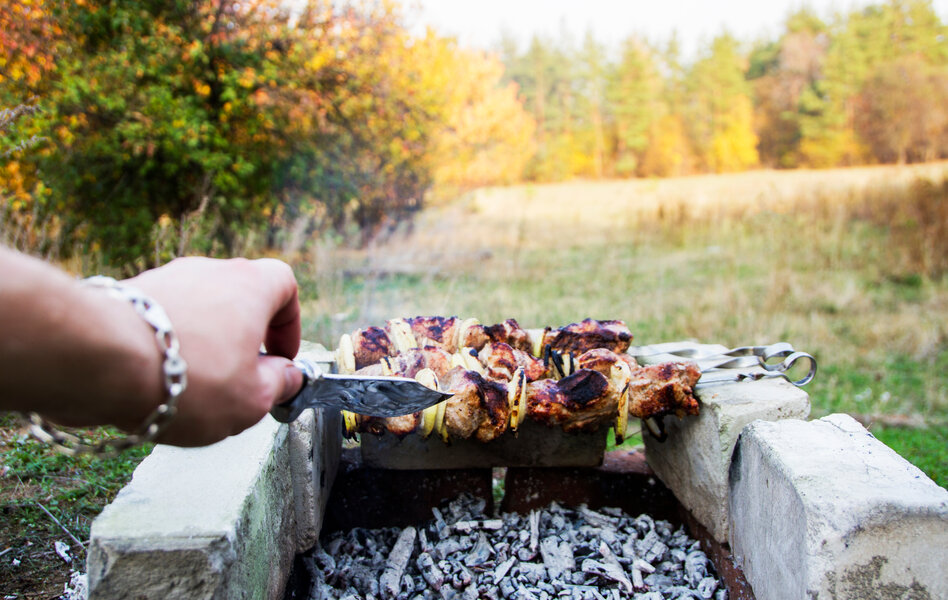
[0,163,948,598]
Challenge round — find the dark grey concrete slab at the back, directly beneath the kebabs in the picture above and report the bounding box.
[361,417,608,469]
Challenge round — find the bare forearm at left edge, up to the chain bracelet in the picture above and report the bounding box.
[0,247,163,429]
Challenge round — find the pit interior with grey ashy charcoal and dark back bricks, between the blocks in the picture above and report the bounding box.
[286,450,740,600]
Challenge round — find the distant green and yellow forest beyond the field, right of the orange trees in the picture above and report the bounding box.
[498,0,948,180]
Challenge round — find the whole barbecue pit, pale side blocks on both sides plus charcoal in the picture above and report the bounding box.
[88,344,948,600]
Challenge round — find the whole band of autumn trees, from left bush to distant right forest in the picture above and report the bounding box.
[0,0,948,271]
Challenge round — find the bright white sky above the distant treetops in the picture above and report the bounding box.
[406,0,948,58]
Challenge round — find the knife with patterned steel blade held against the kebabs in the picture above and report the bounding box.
[270,355,454,423]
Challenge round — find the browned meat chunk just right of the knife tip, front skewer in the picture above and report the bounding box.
[441,367,510,442]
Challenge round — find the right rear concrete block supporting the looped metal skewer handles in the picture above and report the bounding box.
[642,346,810,542]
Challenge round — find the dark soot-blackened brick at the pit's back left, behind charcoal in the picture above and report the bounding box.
[320,448,493,537]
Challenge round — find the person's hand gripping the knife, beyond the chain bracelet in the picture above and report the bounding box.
[127,258,303,446]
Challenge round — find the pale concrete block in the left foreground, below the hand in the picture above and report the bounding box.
[87,416,296,600]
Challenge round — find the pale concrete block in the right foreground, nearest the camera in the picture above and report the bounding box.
[730,415,948,600]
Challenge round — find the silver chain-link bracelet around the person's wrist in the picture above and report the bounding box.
[29,275,188,456]
